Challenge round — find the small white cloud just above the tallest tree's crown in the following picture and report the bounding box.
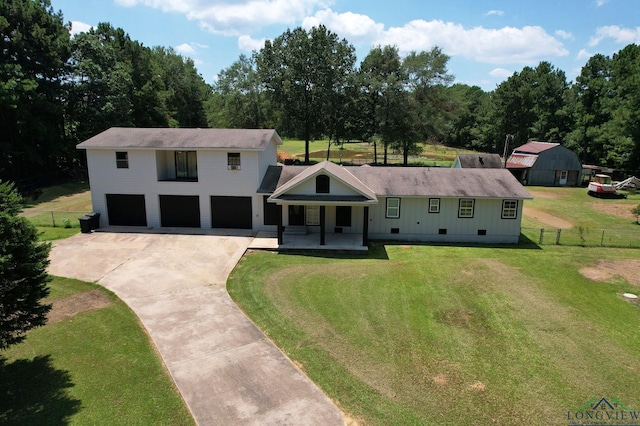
[302,9,384,44]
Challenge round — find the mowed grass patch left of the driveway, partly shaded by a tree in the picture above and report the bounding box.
[0,277,194,425]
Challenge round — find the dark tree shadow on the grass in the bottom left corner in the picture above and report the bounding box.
[0,355,81,425]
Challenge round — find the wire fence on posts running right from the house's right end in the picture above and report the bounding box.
[522,226,640,248]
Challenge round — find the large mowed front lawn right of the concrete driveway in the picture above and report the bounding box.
[228,245,640,425]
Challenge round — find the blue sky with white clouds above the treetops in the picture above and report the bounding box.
[51,0,640,91]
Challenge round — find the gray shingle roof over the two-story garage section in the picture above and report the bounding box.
[77,127,282,150]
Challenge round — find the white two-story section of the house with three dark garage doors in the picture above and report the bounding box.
[78,127,282,229]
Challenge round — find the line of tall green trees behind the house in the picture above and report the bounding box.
[0,0,640,190]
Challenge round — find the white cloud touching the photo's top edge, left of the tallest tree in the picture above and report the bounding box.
[115,0,331,36]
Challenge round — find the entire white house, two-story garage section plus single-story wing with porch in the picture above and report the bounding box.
[78,128,532,245]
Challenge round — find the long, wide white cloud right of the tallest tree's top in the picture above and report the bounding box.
[374,20,569,64]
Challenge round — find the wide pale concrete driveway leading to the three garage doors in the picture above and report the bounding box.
[49,232,344,425]
